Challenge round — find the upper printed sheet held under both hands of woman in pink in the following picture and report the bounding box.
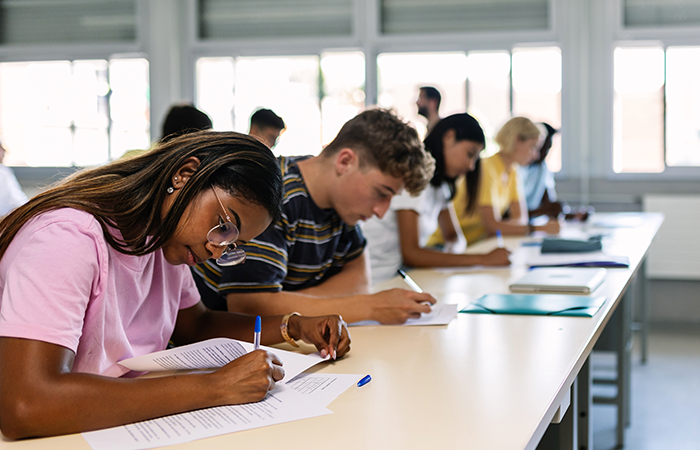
[119,338,325,380]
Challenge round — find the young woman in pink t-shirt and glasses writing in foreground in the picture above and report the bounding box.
[0,132,350,439]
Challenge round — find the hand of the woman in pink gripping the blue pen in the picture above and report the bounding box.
[208,350,284,405]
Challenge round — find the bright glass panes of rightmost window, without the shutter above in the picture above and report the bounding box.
[613,46,700,173]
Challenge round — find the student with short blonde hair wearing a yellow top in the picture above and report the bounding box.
[440,117,559,243]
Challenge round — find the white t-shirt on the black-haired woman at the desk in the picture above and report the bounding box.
[362,184,449,284]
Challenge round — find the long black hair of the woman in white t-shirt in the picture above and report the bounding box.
[423,113,486,213]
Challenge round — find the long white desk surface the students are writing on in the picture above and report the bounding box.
[0,214,663,450]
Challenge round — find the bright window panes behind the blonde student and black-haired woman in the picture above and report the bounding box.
[377,47,562,172]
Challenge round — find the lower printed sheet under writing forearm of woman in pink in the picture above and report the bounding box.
[83,384,332,450]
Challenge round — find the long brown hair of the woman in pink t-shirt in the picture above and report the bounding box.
[0,131,282,258]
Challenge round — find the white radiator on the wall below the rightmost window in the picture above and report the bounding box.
[644,195,700,280]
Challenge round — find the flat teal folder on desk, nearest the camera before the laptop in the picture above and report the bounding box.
[460,294,605,317]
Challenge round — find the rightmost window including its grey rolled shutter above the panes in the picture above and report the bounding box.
[612,0,700,177]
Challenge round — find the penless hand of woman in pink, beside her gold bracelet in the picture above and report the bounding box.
[289,315,350,359]
